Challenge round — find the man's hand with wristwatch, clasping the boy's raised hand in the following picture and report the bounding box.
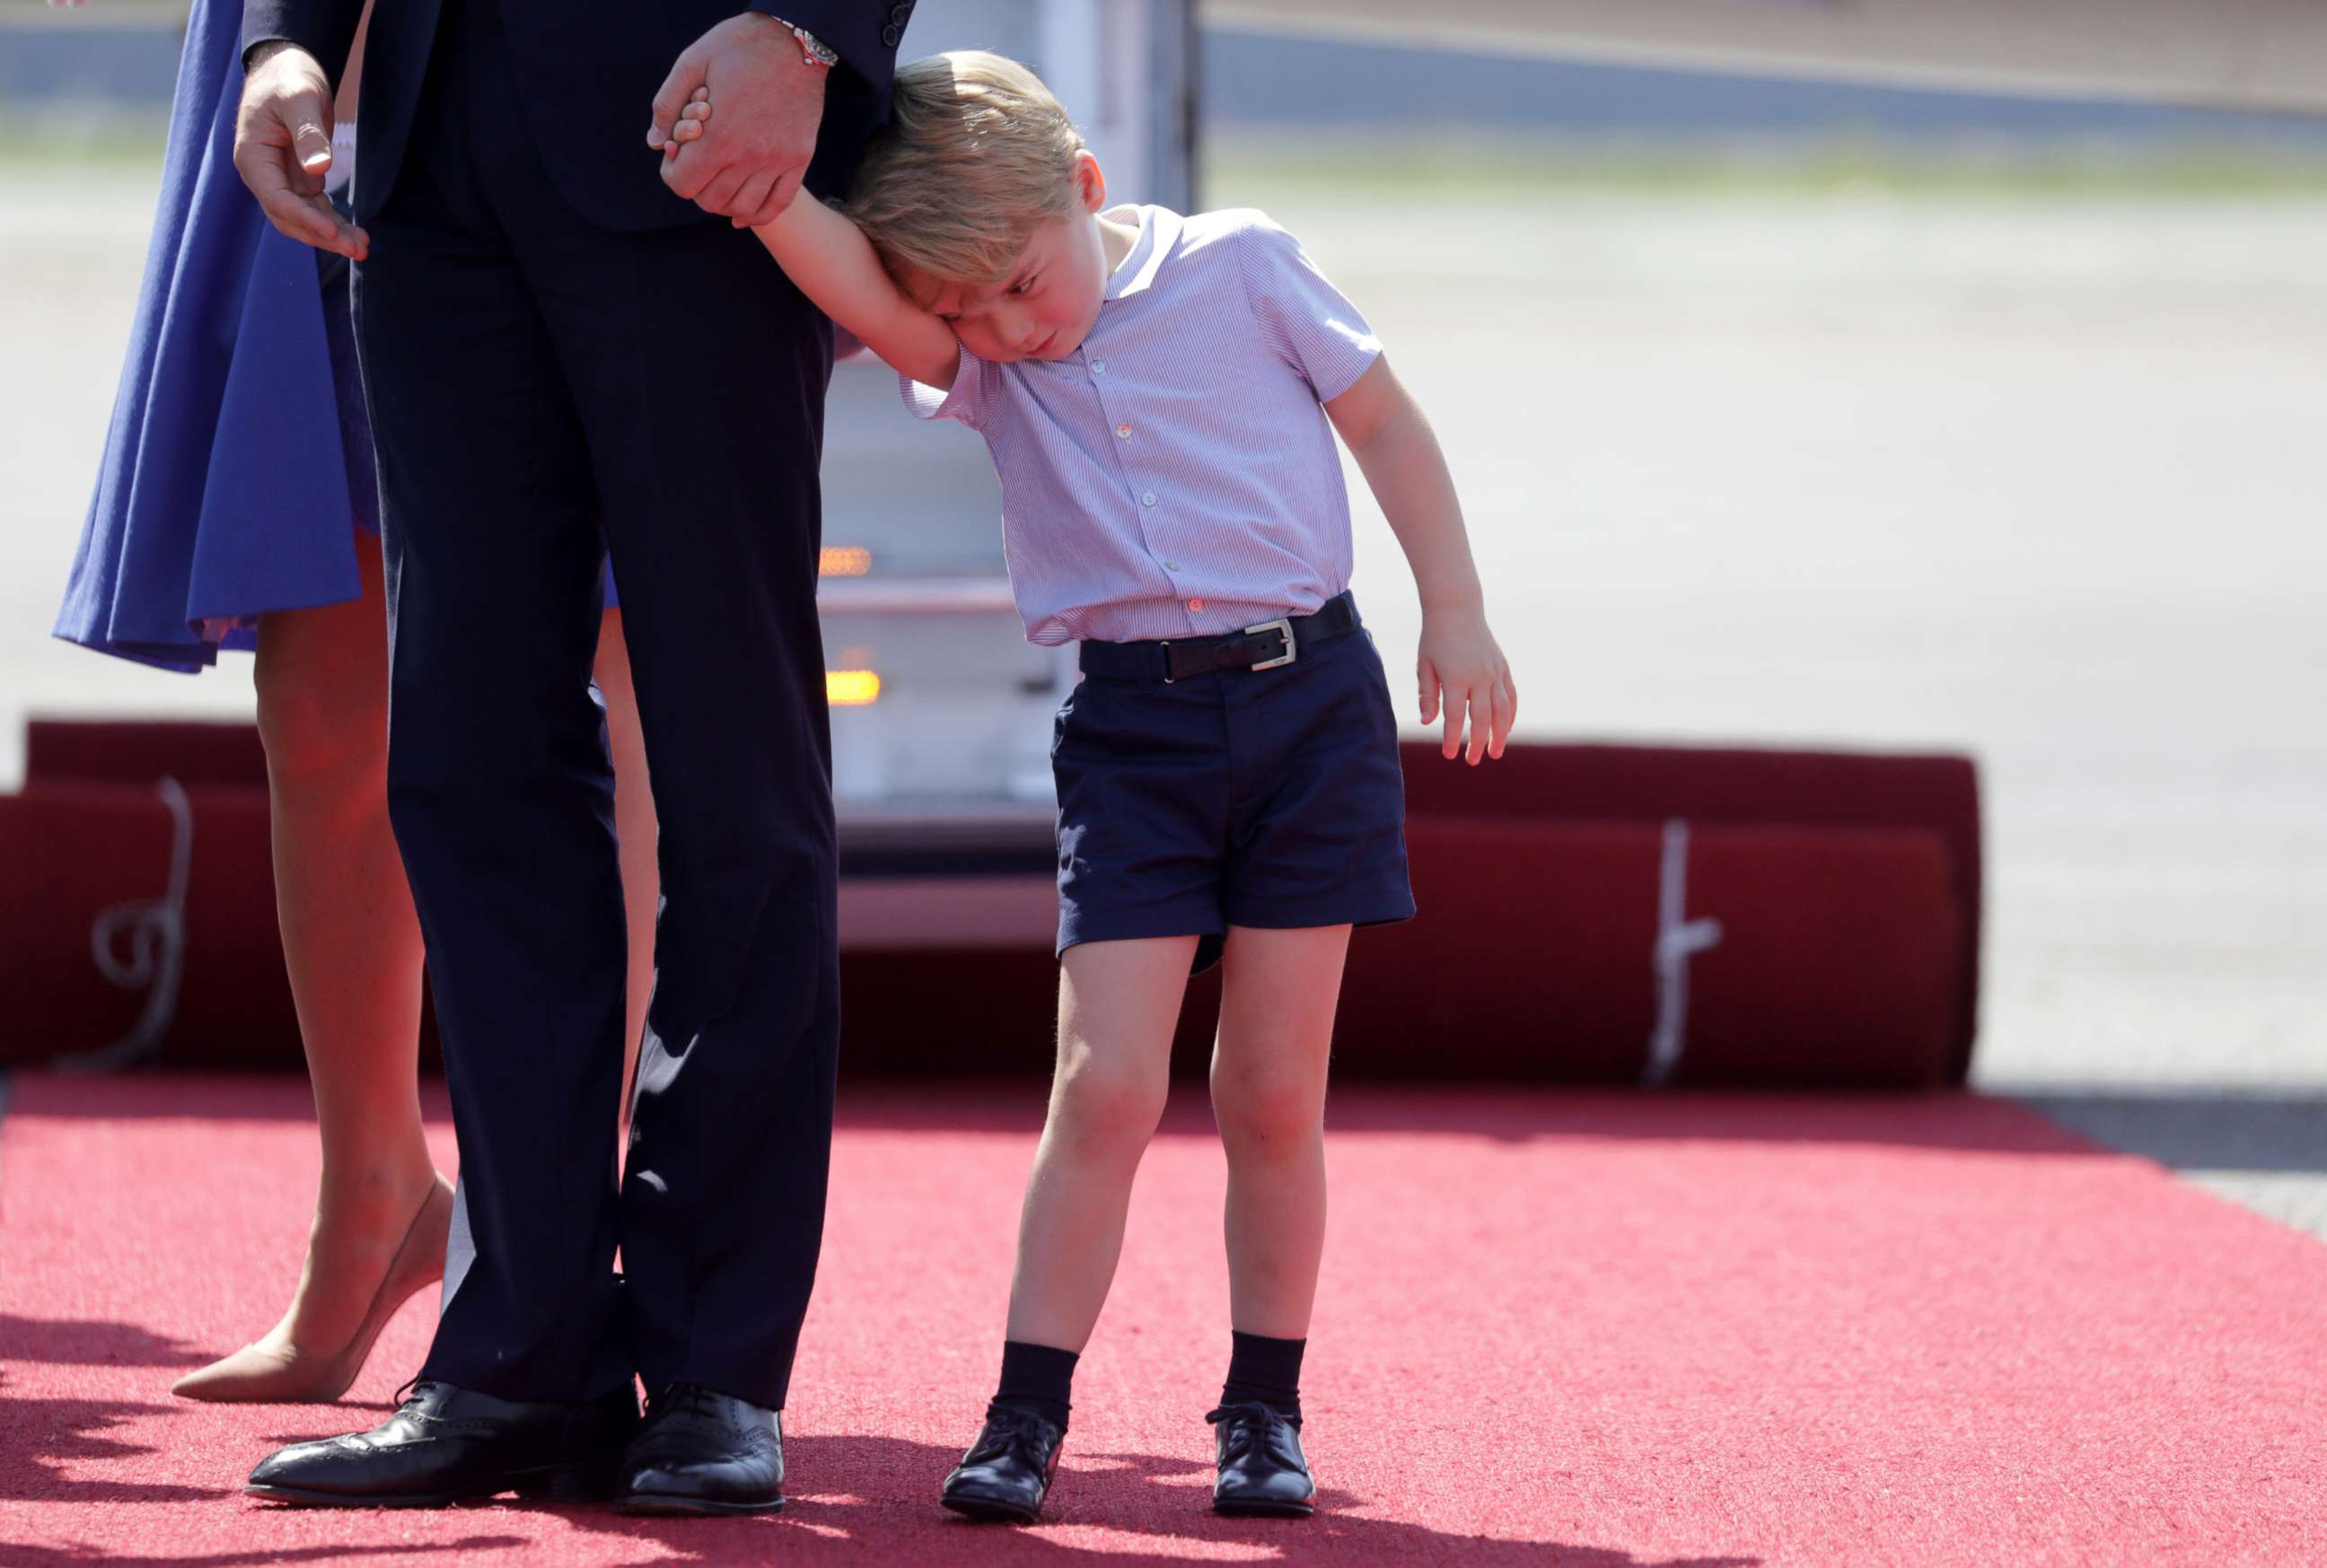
[647,12,824,228]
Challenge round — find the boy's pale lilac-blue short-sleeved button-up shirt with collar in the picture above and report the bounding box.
[903,207,1383,644]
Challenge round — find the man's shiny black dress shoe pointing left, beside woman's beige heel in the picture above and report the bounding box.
[247,1382,637,1508]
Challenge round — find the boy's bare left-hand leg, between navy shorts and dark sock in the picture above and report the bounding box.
[1007,938,1196,1354]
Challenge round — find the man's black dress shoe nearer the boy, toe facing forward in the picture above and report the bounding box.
[614,1382,785,1514]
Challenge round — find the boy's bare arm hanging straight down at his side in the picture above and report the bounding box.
[1324,356,1520,766]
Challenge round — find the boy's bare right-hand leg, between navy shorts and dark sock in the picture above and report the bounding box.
[1212,926,1349,1340]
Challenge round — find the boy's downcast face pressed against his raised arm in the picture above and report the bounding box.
[896,153,1108,363]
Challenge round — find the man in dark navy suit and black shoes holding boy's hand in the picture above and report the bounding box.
[235,0,912,1512]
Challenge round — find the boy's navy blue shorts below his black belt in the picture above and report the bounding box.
[1049,592,1415,972]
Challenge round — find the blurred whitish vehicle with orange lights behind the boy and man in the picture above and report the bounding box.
[819,0,1194,883]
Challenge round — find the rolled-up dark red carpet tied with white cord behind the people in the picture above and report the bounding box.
[0,723,1980,1086]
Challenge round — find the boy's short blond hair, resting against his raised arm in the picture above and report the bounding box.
[847,48,1082,284]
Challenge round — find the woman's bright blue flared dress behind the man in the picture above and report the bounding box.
[56,0,614,672]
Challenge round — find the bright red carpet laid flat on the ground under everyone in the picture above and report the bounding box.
[0,1077,2327,1568]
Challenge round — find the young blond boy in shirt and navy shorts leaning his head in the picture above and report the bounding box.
[670,54,1517,1521]
